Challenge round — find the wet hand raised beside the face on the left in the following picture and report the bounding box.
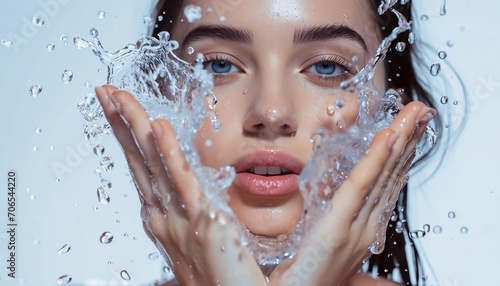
[96,85,265,286]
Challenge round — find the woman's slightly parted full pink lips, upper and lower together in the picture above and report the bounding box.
[233,151,304,197]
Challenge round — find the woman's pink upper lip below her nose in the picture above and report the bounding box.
[233,150,304,174]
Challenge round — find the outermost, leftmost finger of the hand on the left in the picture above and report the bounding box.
[95,85,159,207]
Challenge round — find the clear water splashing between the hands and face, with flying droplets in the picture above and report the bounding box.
[74,0,436,272]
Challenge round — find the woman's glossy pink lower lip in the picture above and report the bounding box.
[233,173,298,197]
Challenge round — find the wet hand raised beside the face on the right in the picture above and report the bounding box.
[270,102,436,285]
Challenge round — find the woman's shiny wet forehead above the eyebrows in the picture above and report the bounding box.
[172,0,380,52]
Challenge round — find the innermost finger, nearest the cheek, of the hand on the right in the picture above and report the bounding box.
[332,129,399,219]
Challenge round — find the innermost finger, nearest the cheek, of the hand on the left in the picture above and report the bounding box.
[151,119,200,209]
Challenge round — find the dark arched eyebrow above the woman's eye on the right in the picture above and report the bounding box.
[293,25,368,51]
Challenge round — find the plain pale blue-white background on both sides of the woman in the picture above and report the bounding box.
[0,0,500,286]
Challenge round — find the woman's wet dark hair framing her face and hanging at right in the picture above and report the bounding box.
[153,0,441,285]
